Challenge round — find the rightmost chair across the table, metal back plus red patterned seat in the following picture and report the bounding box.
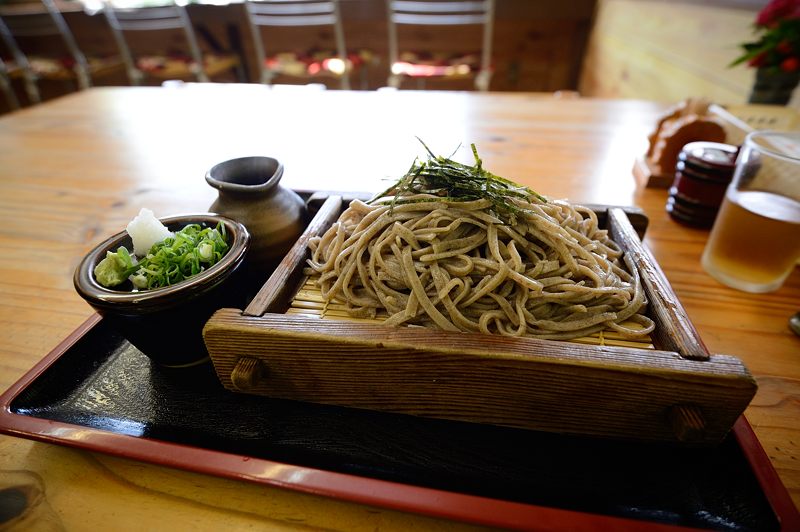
[386,0,494,91]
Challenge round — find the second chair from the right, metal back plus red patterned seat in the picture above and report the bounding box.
[245,0,350,89]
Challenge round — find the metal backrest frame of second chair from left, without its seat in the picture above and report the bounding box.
[103,2,209,85]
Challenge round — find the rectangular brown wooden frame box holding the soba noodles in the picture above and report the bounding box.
[203,196,756,444]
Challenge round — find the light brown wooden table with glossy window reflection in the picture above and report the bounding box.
[0,85,800,530]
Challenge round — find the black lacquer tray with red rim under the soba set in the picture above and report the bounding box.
[0,316,796,531]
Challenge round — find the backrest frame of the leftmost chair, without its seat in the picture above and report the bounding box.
[0,0,92,103]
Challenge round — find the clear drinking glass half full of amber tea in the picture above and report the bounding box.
[702,131,800,293]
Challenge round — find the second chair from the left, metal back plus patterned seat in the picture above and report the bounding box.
[103,2,243,85]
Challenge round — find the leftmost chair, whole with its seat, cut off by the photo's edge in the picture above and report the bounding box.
[0,0,122,103]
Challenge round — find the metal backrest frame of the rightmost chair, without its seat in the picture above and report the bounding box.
[386,0,494,91]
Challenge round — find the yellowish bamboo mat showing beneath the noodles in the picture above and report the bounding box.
[286,277,654,349]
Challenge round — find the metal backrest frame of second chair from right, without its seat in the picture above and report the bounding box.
[245,0,350,89]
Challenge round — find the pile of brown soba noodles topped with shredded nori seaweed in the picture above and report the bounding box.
[307,144,653,339]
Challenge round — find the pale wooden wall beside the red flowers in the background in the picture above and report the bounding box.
[579,0,800,109]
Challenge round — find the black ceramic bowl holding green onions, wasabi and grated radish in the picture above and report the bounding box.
[73,214,250,368]
